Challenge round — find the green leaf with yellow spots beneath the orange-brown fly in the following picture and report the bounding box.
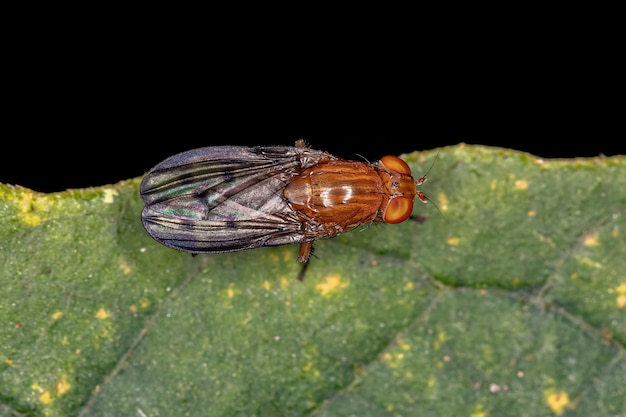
[0,145,626,417]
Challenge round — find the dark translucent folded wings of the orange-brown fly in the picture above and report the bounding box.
[140,146,332,253]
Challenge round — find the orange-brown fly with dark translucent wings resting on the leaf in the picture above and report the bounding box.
[139,140,428,264]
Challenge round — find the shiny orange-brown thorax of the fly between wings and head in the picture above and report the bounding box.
[284,161,385,233]
